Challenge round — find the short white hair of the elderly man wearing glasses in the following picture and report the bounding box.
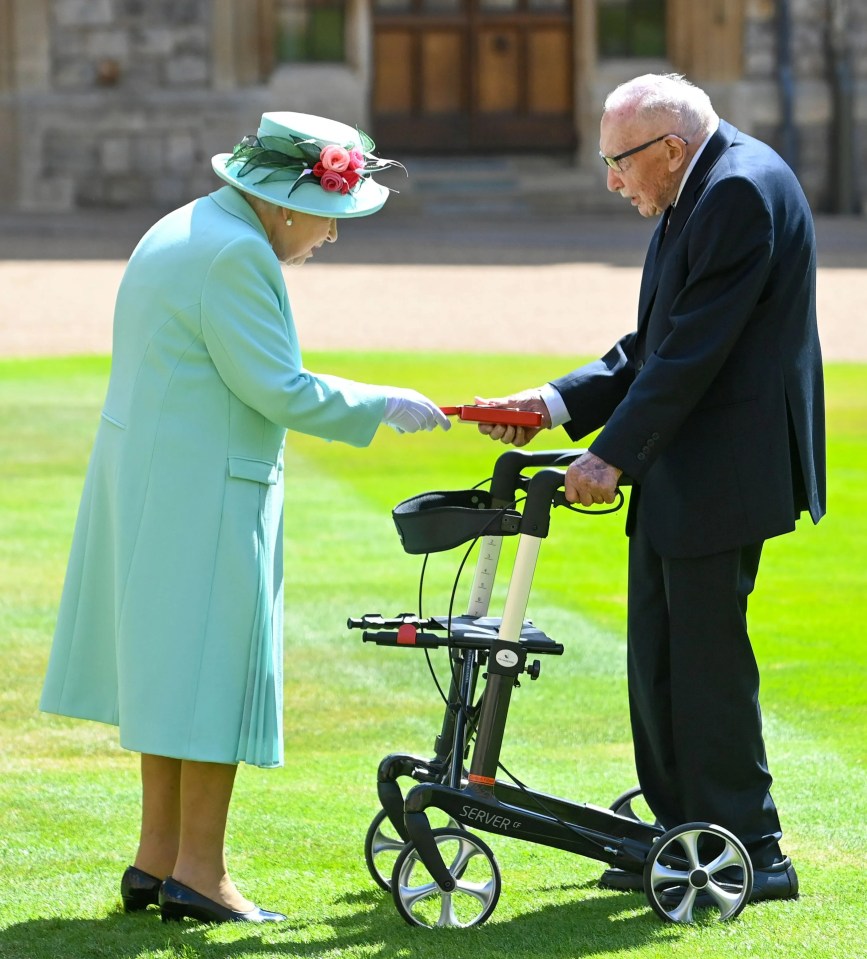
[603,73,718,139]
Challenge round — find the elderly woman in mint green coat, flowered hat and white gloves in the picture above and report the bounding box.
[41,113,448,922]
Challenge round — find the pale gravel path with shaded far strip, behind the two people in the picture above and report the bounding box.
[0,213,867,366]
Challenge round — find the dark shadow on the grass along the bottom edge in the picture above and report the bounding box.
[0,883,678,959]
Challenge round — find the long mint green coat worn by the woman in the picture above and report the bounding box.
[40,187,385,766]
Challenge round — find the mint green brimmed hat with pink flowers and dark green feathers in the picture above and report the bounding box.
[211,113,405,218]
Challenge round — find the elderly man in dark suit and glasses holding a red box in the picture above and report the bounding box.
[480,75,825,901]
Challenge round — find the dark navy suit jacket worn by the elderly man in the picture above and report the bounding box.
[553,121,825,557]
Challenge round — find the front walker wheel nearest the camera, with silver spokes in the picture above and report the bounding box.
[391,828,502,929]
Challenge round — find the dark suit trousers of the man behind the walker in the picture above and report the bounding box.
[627,510,782,868]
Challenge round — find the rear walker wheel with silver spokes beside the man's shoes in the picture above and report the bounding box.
[644,822,753,923]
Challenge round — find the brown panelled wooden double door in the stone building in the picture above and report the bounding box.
[372,0,576,154]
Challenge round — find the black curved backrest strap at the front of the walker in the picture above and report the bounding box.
[391,489,521,553]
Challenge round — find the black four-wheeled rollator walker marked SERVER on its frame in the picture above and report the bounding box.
[348,450,753,927]
